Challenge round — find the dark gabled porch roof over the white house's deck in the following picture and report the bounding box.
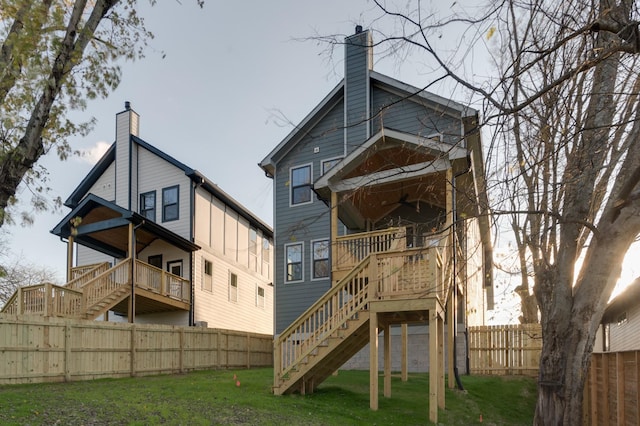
[51,194,200,258]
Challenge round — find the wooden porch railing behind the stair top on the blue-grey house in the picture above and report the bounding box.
[331,227,406,271]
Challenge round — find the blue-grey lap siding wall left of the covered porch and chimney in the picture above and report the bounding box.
[274,104,344,333]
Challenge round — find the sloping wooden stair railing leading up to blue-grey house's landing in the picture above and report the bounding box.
[274,254,375,379]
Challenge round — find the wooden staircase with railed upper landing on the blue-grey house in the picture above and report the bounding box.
[273,233,450,395]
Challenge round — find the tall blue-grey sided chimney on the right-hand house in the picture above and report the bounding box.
[344,25,373,155]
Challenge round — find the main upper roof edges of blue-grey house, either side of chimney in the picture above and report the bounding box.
[258,70,478,176]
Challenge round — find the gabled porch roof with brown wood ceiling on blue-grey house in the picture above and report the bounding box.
[314,129,456,229]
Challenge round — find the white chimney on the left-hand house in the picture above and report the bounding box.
[115,101,140,210]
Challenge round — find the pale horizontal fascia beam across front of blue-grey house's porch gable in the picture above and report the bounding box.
[329,159,451,192]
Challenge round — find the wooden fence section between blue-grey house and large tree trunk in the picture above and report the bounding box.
[469,324,542,377]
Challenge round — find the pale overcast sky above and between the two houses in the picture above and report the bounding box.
[3,0,635,320]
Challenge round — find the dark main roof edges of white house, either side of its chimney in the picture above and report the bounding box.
[66,135,273,237]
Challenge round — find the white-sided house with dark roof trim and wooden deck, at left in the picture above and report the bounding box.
[4,102,273,334]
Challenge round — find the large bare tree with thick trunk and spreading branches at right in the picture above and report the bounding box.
[356,0,640,425]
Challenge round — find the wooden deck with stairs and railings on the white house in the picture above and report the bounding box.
[2,258,191,319]
